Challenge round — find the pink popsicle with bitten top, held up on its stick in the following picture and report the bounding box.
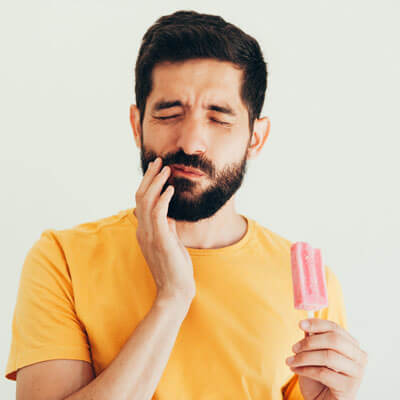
[290,242,328,311]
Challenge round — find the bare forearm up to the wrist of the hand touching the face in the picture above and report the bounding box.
[64,295,191,400]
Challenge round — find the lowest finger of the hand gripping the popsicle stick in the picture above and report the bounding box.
[291,367,352,392]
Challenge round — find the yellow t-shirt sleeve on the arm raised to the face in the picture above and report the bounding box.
[5,230,91,380]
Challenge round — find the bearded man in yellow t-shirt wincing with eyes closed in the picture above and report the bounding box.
[6,11,367,400]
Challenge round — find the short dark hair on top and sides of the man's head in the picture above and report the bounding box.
[135,11,267,135]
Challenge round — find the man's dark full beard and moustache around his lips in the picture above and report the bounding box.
[140,130,251,222]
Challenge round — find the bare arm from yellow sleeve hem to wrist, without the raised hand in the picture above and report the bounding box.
[16,294,191,400]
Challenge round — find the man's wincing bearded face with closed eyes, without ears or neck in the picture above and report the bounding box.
[140,59,250,222]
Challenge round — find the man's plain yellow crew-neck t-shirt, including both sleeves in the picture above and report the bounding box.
[5,208,347,400]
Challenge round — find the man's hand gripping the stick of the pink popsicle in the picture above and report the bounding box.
[286,318,368,400]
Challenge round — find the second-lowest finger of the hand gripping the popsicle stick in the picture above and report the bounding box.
[290,349,362,378]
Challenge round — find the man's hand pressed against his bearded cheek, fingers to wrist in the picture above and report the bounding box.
[135,157,196,302]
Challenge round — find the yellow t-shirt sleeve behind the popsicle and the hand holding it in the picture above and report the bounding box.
[281,266,348,400]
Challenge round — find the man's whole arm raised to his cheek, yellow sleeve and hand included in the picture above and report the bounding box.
[14,158,195,400]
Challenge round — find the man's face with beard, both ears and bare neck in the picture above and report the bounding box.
[130,59,270,249]
